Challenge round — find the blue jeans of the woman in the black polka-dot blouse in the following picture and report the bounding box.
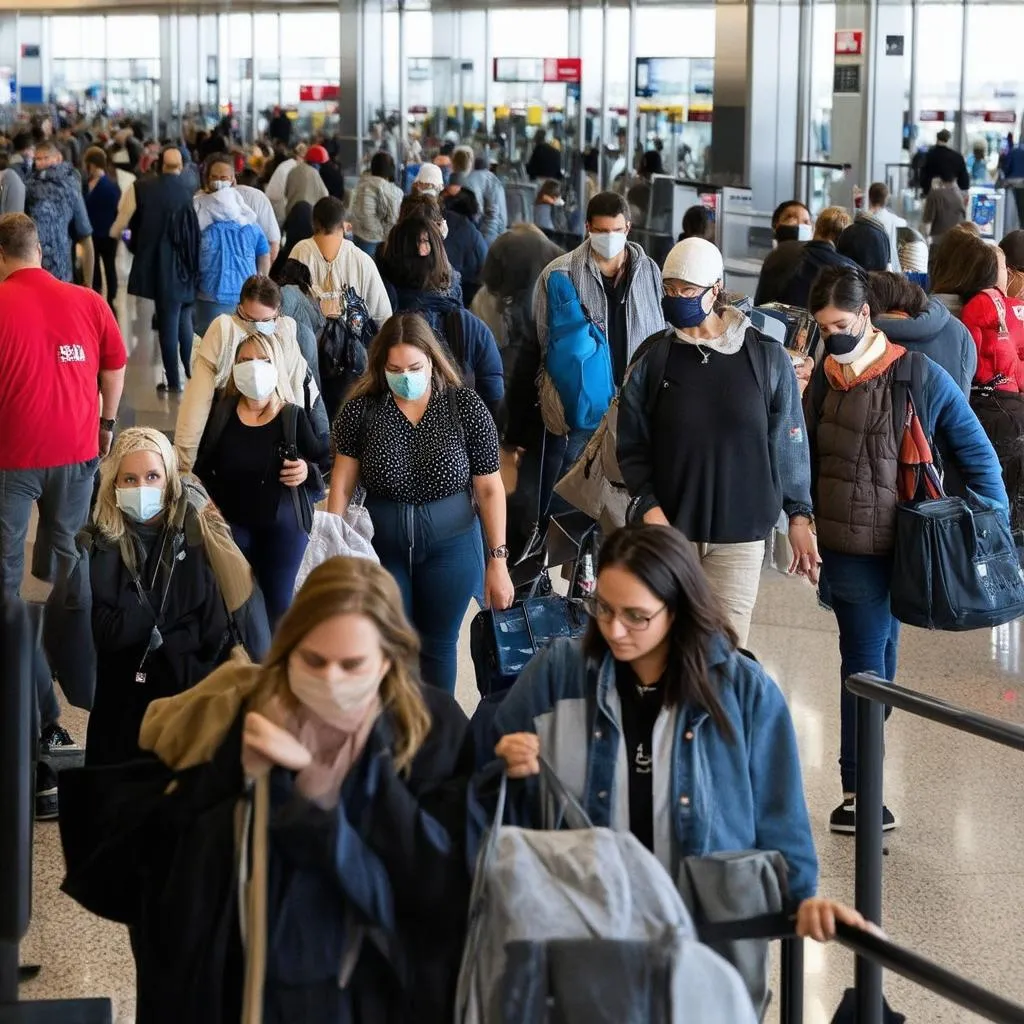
[367,494,483,693]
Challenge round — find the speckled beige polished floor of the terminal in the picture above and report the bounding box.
[14,292,1024,1024]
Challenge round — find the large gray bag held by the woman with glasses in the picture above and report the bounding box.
[456,765,757,1024]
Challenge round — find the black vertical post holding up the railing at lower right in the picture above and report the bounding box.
[855,697,884,1024]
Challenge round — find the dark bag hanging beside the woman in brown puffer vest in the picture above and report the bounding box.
[890,382,1024,631]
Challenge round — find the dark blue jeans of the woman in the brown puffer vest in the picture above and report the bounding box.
[821,548,899,793]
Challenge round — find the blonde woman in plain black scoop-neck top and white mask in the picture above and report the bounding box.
[195,334,328,628]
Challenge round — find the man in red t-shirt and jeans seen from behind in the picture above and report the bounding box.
[0,213,127,818]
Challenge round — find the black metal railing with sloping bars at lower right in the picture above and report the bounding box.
[839,674,1024,1024]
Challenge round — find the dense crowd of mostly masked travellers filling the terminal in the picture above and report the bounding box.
[0,108,1024,1024]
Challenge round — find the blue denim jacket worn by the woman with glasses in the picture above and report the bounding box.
[495,637,818,901]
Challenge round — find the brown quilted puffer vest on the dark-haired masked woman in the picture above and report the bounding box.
[814,367,899,555]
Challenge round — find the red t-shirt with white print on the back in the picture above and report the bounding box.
[0,269,128,470]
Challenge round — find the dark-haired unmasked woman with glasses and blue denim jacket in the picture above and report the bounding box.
[495,526,863,954]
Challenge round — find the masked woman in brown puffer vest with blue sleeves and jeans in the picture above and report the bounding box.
[805,268,1007,833]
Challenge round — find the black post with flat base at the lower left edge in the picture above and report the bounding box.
[0,596,113,1024]
